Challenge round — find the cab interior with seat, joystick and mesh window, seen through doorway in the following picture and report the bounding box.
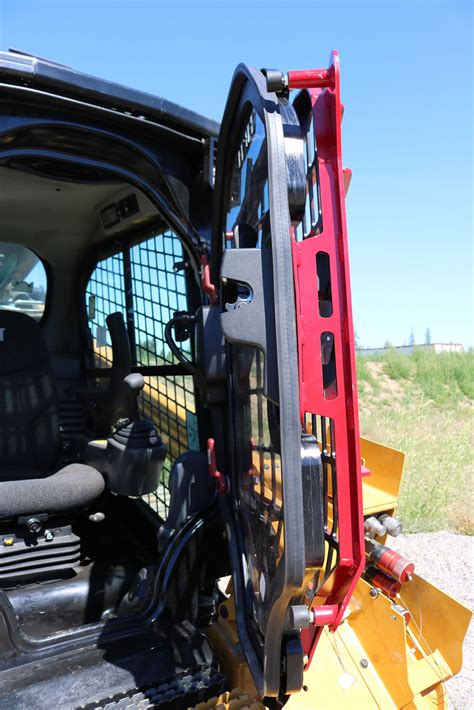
[0,161,229,702]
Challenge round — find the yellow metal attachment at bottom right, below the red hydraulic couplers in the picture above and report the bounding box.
[285,575,471,710]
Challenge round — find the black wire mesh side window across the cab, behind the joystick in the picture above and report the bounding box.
[86,232,199,517]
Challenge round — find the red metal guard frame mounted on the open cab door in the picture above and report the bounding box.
[288,52,365,660]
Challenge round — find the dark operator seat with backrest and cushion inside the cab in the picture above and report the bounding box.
[0,310,105,519]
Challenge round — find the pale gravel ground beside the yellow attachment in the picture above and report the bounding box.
[390,531,474,710]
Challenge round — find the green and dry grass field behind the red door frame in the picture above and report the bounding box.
[357,349,474,534]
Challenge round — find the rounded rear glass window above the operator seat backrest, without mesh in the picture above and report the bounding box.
[0,242,47,321]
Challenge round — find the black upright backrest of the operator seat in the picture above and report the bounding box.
[0,310,60,470]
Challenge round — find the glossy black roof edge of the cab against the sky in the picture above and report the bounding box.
[0,49,220,139]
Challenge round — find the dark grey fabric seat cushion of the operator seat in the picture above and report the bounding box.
[0,463,105,518]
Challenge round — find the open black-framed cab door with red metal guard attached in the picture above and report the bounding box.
[210,53,364,697]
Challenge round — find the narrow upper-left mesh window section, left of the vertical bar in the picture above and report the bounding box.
[86,253,126,367]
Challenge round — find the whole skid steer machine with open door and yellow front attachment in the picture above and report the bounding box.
[0,52,470,710]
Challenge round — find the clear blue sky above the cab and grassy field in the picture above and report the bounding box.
[0,0,474,346]
